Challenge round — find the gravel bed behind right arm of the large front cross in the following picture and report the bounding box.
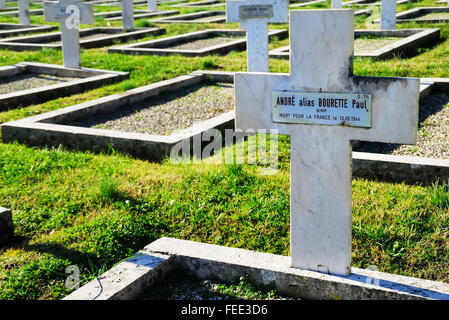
[354,91,449,159]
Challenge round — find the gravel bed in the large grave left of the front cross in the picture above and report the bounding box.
[66,83,234,135]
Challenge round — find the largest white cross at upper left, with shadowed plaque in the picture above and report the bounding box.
[44,0,94,68]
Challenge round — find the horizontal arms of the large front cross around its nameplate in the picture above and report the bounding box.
[235,73,419,144]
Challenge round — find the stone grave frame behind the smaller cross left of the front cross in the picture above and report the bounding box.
[108,29,288,57]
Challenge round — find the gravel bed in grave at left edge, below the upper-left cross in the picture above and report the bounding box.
[0,74,79,94]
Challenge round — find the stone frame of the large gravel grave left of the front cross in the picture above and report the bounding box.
[1,71,234,161]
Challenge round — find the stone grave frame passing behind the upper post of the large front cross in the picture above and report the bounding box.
[270,29,440,59]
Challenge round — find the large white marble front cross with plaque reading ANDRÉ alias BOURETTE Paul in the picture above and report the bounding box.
[235,9,419,274]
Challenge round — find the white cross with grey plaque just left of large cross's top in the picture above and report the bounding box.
[226,0,288,72]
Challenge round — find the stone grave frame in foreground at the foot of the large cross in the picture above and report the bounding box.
[63,237,449,300]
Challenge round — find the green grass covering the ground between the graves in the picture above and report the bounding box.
[0,0,449,299]
